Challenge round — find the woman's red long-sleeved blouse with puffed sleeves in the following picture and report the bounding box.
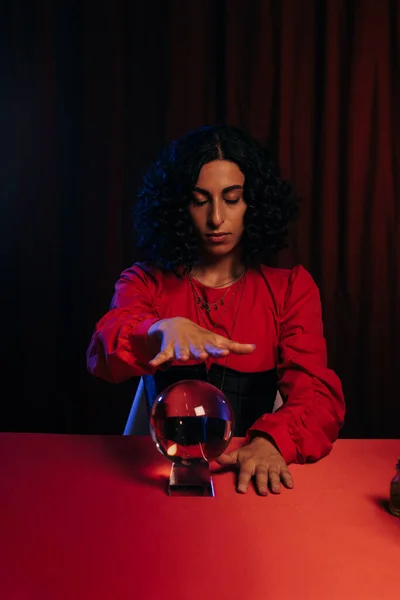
[87,263,345,463]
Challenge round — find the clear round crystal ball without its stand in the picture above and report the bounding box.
[150,379,234,465]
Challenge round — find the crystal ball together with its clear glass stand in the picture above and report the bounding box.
[150,380,234,497]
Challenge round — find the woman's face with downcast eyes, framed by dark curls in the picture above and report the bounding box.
[189,160,247,256]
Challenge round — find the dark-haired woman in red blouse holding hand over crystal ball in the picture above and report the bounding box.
[87,126,345,495]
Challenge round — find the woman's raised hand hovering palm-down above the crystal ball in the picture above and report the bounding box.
[147,317,255,367]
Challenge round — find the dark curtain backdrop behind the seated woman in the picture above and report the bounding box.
[0,0,400,437]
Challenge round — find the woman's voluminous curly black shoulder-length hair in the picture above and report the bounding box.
[134,125,298,273]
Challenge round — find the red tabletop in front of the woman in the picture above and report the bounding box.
[0,433,400,600]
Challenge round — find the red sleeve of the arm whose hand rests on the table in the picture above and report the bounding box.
[249,267,345,463]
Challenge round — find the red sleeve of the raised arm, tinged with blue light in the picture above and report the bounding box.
[87,264,161,383]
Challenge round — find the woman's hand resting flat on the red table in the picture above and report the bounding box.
[216,437,293,496]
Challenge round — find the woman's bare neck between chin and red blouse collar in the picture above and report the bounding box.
[191,248,244,287]
